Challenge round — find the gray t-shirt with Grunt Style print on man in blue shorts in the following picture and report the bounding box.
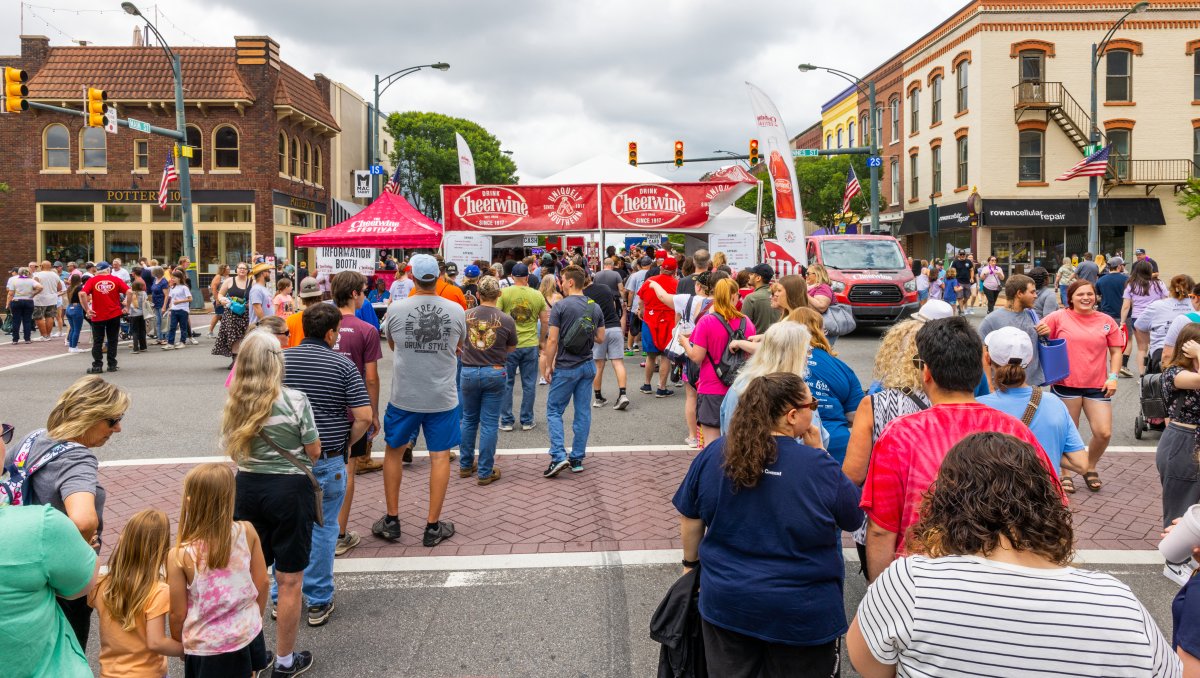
[383,294,467,412]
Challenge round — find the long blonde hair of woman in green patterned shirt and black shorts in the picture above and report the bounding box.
[221,330,283,462]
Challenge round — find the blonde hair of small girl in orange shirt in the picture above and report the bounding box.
[97,509,170,631]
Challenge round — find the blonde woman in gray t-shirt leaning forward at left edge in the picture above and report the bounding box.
[5,376,130,647]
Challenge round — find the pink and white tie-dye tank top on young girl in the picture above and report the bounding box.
[184,523,263,656]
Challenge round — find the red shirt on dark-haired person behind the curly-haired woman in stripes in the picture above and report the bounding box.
[860,403,1062,558]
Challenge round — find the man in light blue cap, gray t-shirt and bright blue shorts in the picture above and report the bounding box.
[371,254,467,546]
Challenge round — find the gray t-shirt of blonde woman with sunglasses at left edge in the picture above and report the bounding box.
[5,430,106,538]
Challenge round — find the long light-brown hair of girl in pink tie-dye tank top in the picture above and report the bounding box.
[178,463,236,570]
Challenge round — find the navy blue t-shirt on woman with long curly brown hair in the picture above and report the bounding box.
[673,436,863,646]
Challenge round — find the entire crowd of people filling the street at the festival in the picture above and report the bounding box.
[11,238,1200,677]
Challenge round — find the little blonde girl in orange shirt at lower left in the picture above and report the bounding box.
[88,508,184,678]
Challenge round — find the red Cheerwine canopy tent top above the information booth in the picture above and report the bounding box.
[295,193,442,248]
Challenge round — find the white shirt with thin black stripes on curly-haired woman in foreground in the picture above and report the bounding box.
[858,556,1182,677]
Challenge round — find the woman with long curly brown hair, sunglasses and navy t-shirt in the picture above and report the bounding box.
[673,372,863,677]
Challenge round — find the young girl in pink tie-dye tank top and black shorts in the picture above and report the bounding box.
[167,463,272,678]
